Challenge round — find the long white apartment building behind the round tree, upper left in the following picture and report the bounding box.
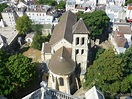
[25,5,54,24]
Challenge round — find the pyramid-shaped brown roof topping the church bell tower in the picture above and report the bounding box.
[72,18,89,34]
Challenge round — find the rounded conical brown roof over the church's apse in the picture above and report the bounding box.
[48,47,76,75]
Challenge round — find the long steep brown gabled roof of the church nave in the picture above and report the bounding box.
[49,11,77,45]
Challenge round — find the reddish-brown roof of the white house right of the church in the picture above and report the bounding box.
[114,31,127,47]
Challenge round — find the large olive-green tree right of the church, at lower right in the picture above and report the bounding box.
[83,50,132,95]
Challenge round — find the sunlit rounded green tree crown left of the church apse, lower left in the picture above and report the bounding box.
[6,54,35,87]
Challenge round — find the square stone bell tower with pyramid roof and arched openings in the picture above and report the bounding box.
[72,18,90,79]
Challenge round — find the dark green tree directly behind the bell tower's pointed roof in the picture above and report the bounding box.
[77,10,110,39]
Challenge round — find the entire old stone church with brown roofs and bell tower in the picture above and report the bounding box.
[42,11,90,94]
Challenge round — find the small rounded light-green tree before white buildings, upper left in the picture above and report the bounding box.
[16,15,32,34]
